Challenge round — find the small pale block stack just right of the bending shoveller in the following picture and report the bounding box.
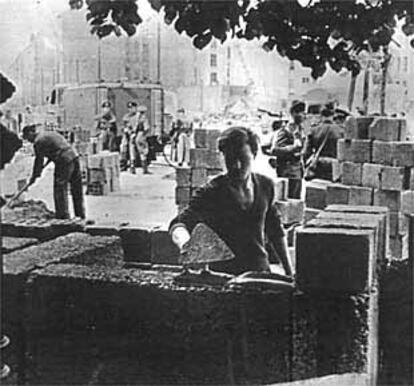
[87,151,121,196]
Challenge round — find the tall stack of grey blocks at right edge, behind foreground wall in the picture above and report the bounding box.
[326,117,414,258]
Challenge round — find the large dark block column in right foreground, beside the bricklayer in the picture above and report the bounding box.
[293,205,388,384]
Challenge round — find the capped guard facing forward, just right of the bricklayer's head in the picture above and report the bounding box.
[271,100,305,199]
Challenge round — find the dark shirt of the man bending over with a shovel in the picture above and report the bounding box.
[32,131,78,177]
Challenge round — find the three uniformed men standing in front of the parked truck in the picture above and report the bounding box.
[98,101,150,174]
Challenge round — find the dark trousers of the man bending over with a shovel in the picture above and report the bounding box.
[53,158,85,219]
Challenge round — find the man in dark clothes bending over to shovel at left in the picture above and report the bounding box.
[23,125,85,219]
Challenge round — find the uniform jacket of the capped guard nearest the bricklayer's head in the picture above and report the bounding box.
[271,122,304,178]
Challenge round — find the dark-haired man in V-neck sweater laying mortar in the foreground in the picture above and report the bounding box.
[170,127,292,276]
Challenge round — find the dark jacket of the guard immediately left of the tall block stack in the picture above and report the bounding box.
[303,119,343,159]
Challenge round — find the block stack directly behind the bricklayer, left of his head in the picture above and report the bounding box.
[175,129,224,211]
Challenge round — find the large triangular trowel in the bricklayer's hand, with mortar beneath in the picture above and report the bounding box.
[175,223,235,287]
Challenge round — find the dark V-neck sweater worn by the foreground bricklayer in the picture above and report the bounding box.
[170,173,284,274]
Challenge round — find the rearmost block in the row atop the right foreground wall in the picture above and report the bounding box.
[325,205,390,258]
